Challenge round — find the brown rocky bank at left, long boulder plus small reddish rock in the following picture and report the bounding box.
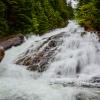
[0,34,24,62]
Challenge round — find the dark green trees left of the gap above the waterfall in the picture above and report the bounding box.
[0,0,73,35]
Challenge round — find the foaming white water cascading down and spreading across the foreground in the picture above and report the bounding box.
[0,21,100,100]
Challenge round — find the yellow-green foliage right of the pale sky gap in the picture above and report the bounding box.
[76,0,100,31]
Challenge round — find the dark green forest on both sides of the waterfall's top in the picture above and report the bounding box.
[0,0,100,36]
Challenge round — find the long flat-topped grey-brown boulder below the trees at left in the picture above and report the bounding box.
[0,35,24,50]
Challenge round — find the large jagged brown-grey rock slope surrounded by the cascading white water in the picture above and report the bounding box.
[15,33,64,72]
